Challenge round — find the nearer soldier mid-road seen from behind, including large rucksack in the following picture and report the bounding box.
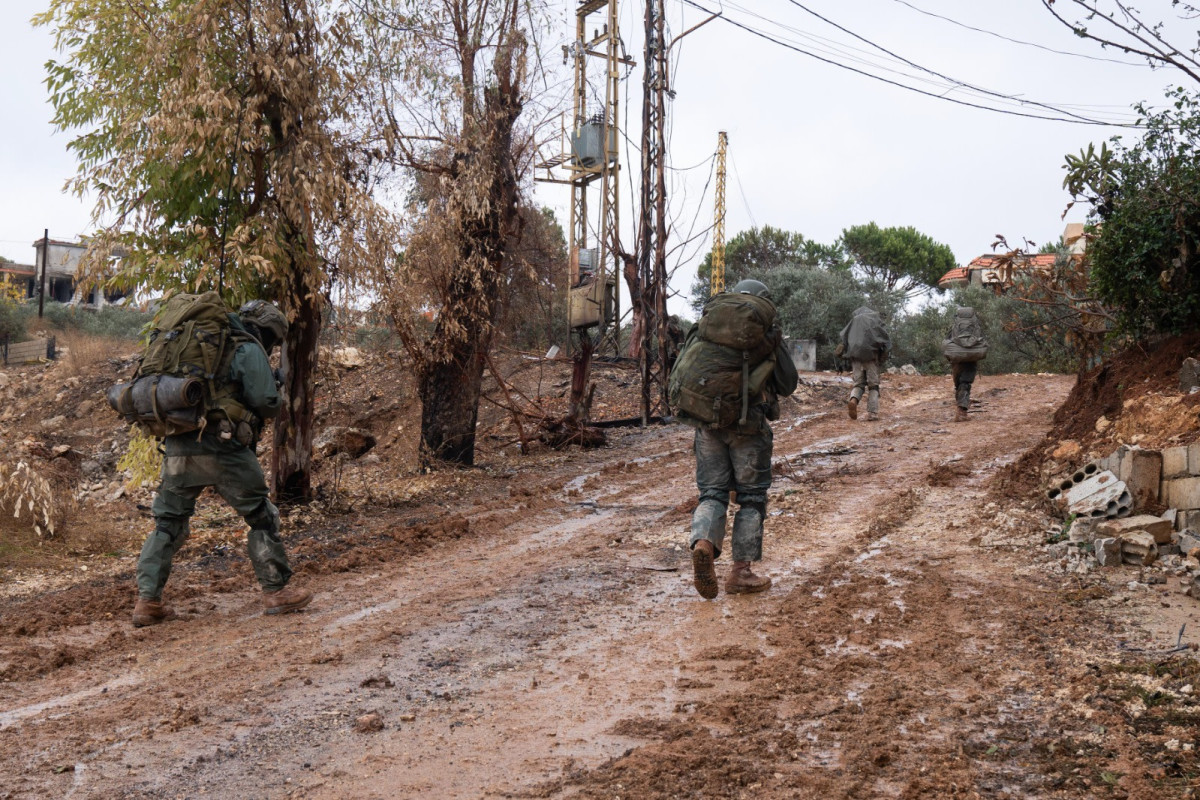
[671,281,798,600]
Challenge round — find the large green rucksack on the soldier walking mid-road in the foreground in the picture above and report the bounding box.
[667,294,779,428]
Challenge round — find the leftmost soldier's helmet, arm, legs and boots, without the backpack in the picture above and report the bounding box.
[133,300,312,627]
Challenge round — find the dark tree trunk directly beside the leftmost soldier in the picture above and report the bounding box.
[271,265,323,504]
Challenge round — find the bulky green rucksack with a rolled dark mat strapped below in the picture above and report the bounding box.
[108,291,253,437]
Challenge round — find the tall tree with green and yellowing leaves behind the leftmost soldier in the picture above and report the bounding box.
[36,0,396,501]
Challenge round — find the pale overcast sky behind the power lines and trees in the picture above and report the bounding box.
[0,0,1195,319]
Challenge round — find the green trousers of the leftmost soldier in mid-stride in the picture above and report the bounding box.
[137,447,292,597]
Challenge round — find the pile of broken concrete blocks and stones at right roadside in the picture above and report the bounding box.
[1046,443,1200,599]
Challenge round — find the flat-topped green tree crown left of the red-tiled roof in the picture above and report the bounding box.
[839,222,958,297]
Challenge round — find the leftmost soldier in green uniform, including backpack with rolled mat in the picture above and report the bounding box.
[109,291,312,627]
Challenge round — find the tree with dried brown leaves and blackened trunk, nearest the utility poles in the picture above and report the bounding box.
[360,0,541,469]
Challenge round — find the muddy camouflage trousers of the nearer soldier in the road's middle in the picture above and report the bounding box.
[689,416,774,561]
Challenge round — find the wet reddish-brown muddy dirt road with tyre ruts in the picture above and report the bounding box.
[0,375,1182,799]
